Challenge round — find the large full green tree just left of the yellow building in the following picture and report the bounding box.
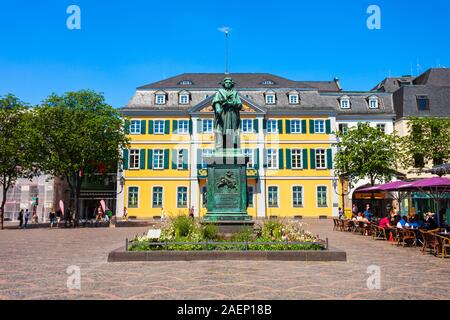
[35,90,128,222]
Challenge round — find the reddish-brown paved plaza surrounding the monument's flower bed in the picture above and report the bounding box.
[0,220,450,300]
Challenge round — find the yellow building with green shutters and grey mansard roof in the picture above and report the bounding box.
[117,74,341,219]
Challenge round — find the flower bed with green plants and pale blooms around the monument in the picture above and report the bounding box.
[126,216,328,251]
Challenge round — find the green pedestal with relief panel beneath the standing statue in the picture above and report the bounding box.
[204,149,254,226]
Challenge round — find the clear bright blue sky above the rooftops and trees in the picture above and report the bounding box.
[0,0,450,107]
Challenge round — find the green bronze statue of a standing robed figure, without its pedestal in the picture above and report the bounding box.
[212,77,242,150]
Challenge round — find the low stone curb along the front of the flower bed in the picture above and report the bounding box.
[108,247,347,262]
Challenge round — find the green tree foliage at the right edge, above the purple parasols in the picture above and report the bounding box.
[402,117,450,169]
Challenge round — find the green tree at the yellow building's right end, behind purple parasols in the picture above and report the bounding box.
[334,123,398,186]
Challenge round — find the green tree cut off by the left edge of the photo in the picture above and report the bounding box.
[0,94,37,230]
